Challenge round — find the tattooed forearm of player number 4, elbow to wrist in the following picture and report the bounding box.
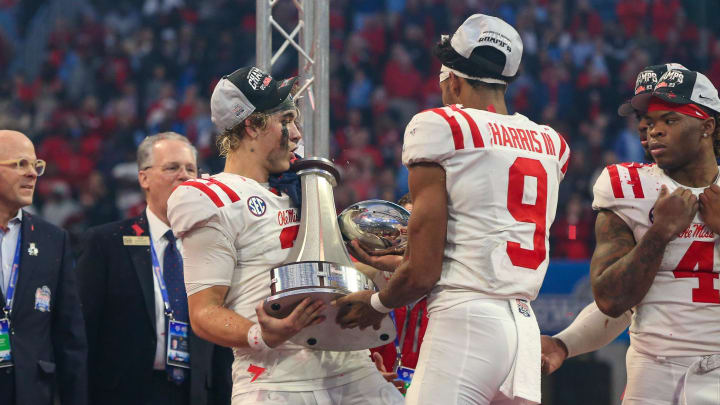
[591,227,670,317]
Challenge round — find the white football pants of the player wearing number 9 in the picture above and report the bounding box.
[405,299,532,405]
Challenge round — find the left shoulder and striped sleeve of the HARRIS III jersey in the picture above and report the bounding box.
[402,108,455,166]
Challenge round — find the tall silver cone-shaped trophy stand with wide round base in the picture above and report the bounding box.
[264,157,396,351]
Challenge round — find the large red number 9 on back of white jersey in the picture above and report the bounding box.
[507,157,547,270]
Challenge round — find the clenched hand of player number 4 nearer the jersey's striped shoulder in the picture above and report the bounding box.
[651,185,699,240]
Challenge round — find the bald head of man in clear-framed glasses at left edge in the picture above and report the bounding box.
[0,130,37,219]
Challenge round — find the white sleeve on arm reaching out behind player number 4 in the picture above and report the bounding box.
[555,301,632,358]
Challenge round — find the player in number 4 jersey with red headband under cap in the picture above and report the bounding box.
[591,69,720,405]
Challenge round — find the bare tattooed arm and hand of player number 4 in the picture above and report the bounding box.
[590,186,698,317]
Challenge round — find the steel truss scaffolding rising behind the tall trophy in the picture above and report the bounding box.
[255,0,330,157]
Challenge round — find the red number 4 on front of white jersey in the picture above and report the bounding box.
[673,241,720,304]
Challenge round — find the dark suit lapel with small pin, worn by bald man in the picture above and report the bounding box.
[11,211,40,317]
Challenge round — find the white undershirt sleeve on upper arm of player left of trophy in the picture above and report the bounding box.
[182,223,237,296]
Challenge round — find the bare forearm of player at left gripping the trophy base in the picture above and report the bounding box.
[188,296,253,347]
